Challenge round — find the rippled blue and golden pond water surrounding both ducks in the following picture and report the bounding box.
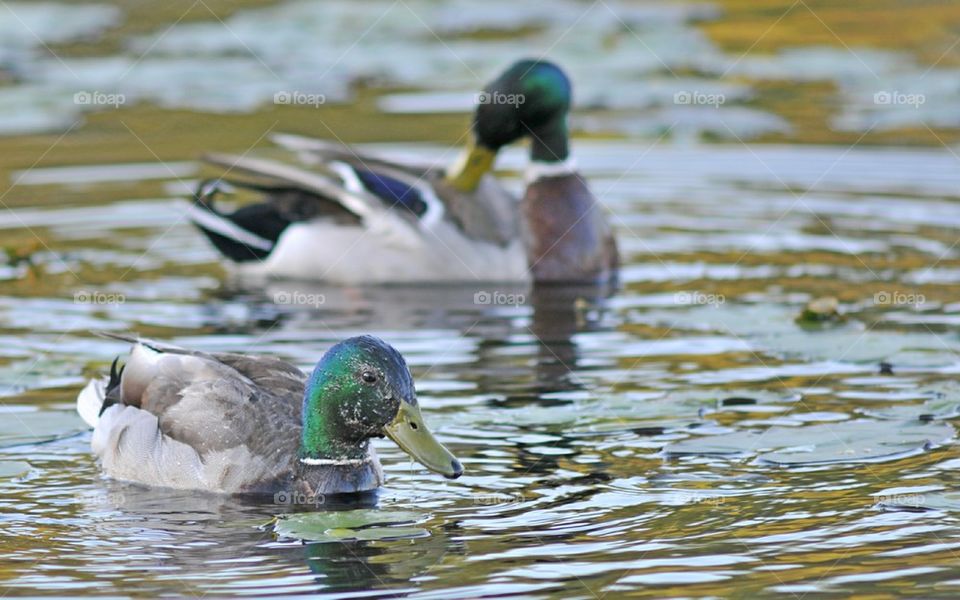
[0,0,960,599]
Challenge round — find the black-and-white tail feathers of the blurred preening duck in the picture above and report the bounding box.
[190,179,290,262]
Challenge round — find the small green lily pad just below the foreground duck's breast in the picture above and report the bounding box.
[273,509,430,542]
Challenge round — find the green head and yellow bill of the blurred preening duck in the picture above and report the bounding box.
[447,59,573,190]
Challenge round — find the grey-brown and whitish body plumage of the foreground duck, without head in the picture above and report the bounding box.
[78,336,383,494]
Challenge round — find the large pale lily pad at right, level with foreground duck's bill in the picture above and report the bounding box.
[663,419,956,466]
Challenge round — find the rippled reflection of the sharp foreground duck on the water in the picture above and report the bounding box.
[85,480,465,596]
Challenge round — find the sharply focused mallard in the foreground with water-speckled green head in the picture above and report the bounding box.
[77,333,463,498]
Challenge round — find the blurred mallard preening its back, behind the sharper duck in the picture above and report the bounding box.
[188,59,619,284]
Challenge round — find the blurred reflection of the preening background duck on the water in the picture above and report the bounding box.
[223,281,615,395]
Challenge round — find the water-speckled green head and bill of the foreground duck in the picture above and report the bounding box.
[300,335,463,479]
